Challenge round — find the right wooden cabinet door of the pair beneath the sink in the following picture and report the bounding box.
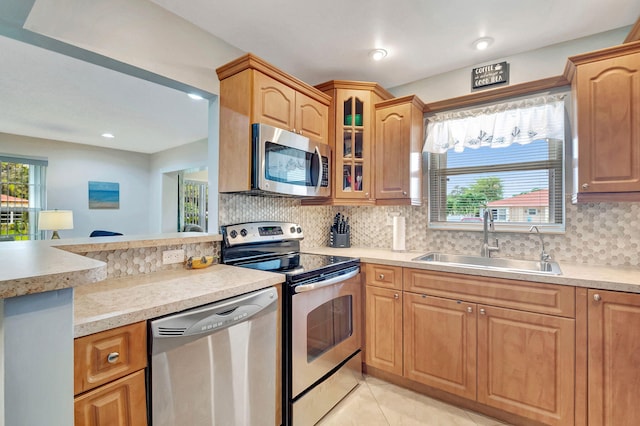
[478,305,575,425]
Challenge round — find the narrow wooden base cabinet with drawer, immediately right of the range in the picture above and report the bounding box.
[365,264,402,375]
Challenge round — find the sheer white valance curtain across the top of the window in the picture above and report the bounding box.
[423,94,564,154]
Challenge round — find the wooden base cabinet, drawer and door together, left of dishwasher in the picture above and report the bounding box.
[74,321,147,426]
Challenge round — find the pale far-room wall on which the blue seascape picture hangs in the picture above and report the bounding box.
[0,133,152,238]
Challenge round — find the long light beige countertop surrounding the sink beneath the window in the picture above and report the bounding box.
[303,247,640,293]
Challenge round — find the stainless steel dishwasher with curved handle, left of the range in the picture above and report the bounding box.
[150,288,279,426]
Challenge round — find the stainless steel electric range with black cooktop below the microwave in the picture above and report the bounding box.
[222,222,362,426]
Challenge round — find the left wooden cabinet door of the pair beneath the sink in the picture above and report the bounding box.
[404,293,477,399]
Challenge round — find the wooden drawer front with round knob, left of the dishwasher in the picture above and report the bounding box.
[73,321,147,395]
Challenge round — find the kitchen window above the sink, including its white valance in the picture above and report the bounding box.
[424,95,565,232]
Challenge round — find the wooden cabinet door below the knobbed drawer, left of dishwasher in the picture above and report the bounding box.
[74,371,147,426]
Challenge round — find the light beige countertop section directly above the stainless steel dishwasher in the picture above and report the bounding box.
[74,265,284,337]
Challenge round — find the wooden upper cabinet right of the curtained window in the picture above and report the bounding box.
[565,42,640,202]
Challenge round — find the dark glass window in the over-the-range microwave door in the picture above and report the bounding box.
[264,141,324,187]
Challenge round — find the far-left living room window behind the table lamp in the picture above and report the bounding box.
[0,156,47,242]
